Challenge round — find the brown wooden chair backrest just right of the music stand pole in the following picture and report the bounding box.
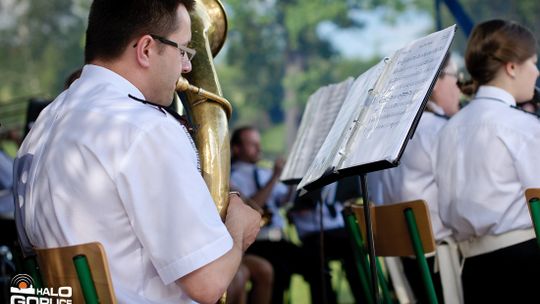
[352,200,435,256]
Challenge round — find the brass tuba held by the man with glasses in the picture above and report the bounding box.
[176,0,232,219]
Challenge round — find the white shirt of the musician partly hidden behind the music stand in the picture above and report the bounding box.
[369,102,451,240]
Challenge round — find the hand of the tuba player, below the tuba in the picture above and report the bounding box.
[225,194,261,251]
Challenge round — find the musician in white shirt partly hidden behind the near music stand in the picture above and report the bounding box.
[369,56,460,303]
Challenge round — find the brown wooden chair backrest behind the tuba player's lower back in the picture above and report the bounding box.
[34,242,116,303]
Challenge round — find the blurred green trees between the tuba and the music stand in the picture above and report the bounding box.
[219,0,372,152]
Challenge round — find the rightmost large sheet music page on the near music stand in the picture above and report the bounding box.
[339,27,455,168]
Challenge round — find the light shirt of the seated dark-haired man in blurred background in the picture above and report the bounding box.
[231,161,289,239]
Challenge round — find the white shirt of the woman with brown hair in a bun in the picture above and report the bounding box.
[436,86,540,241]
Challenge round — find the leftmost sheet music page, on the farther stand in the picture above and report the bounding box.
[280,77,353,182]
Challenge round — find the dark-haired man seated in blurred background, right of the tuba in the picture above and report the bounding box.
[231,126,321,304]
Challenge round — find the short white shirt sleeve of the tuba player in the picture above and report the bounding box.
[117,121,233,284]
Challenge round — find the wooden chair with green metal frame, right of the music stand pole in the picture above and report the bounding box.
[351,200,438,303]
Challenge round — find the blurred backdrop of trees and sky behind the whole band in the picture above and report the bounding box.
[0,0,540,159]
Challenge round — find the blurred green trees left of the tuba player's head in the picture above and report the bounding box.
[0,0,90,100]
